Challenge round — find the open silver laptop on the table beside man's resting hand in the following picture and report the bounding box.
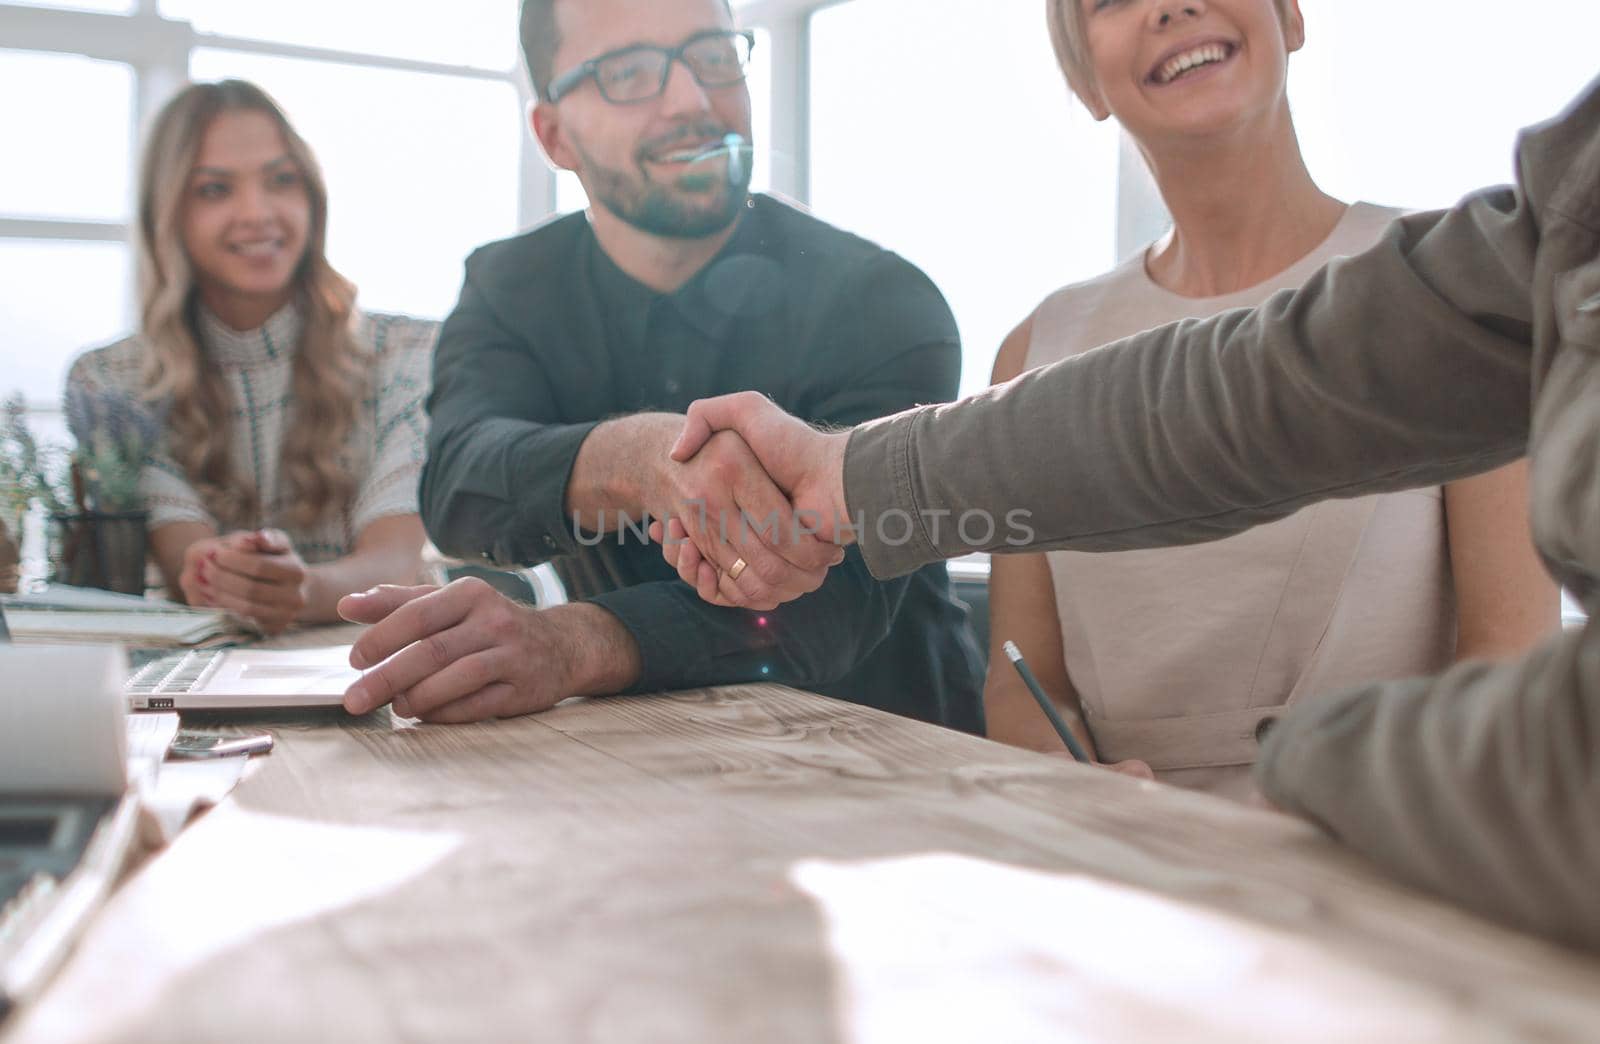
[125,645,362,711]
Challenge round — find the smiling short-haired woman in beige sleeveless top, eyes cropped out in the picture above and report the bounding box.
[984,0,1560,797]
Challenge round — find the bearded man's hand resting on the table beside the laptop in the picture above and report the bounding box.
[339,578,640,724]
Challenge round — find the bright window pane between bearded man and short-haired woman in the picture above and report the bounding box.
[811,0,1117,394]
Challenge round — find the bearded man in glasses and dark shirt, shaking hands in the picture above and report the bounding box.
[336,0,982,732]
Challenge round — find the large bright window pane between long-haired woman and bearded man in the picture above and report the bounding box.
[190,50,523,317]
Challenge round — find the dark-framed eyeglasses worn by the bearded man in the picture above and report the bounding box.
[544,29,755,106]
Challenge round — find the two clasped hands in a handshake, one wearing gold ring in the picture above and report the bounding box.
[650,392,854,610]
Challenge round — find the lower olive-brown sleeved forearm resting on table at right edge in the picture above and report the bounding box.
[1258,621,1600,950]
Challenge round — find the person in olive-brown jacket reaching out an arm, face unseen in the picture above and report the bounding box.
[664,73,1600,950]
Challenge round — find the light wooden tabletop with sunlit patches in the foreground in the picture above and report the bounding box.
[0,630,1600,1044]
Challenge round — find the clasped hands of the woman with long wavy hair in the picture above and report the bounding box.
[178,530,312,634]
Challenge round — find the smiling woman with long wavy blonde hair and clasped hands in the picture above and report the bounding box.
[67,80,435,632]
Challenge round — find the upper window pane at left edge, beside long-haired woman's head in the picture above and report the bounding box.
[0,50,133,221]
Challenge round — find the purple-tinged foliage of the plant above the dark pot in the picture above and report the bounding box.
[67,387,160,514]
